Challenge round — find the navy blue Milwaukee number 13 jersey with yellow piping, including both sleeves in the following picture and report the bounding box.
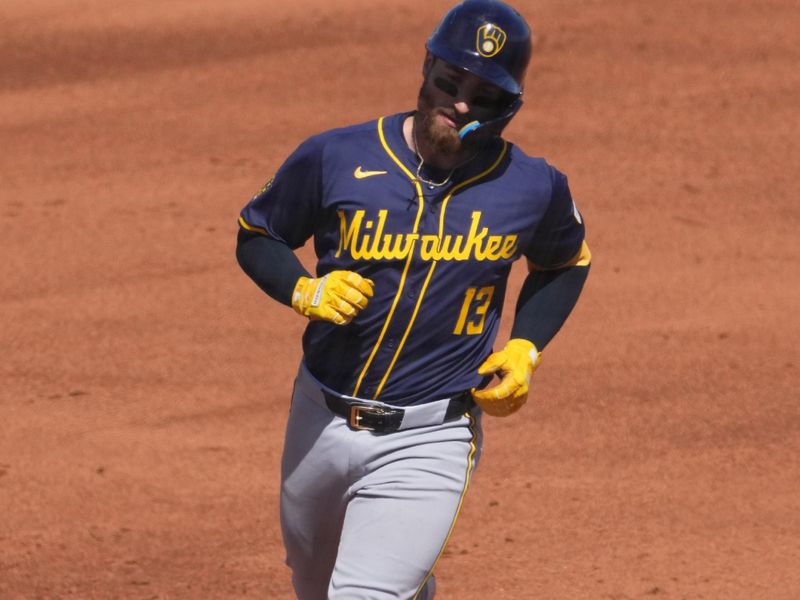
[240,113,584,405]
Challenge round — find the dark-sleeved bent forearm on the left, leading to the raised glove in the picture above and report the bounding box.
[236,229,308,306]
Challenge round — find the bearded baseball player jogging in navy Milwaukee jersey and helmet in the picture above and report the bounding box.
[237,0,590,600]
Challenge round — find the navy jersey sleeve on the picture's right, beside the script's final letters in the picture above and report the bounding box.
[524,167,585,270]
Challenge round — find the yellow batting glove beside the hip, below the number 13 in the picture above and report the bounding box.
[472,338,542,417]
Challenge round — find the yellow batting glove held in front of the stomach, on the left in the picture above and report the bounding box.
[292,271,375,325]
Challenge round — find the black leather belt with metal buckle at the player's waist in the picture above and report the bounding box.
[322,390,474,433]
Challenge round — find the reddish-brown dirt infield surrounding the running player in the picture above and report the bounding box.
[0,0,800,600]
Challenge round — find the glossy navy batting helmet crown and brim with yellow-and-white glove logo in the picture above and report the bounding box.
[426,0,531,96]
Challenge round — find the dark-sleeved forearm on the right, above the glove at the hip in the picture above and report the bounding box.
[511,266,589,351]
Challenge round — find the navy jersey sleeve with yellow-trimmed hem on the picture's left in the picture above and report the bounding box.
[239,138,323,249]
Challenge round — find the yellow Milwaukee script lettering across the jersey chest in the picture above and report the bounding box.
[336,210,517,261]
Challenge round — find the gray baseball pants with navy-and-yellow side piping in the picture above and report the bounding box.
[280,366,482,600]
